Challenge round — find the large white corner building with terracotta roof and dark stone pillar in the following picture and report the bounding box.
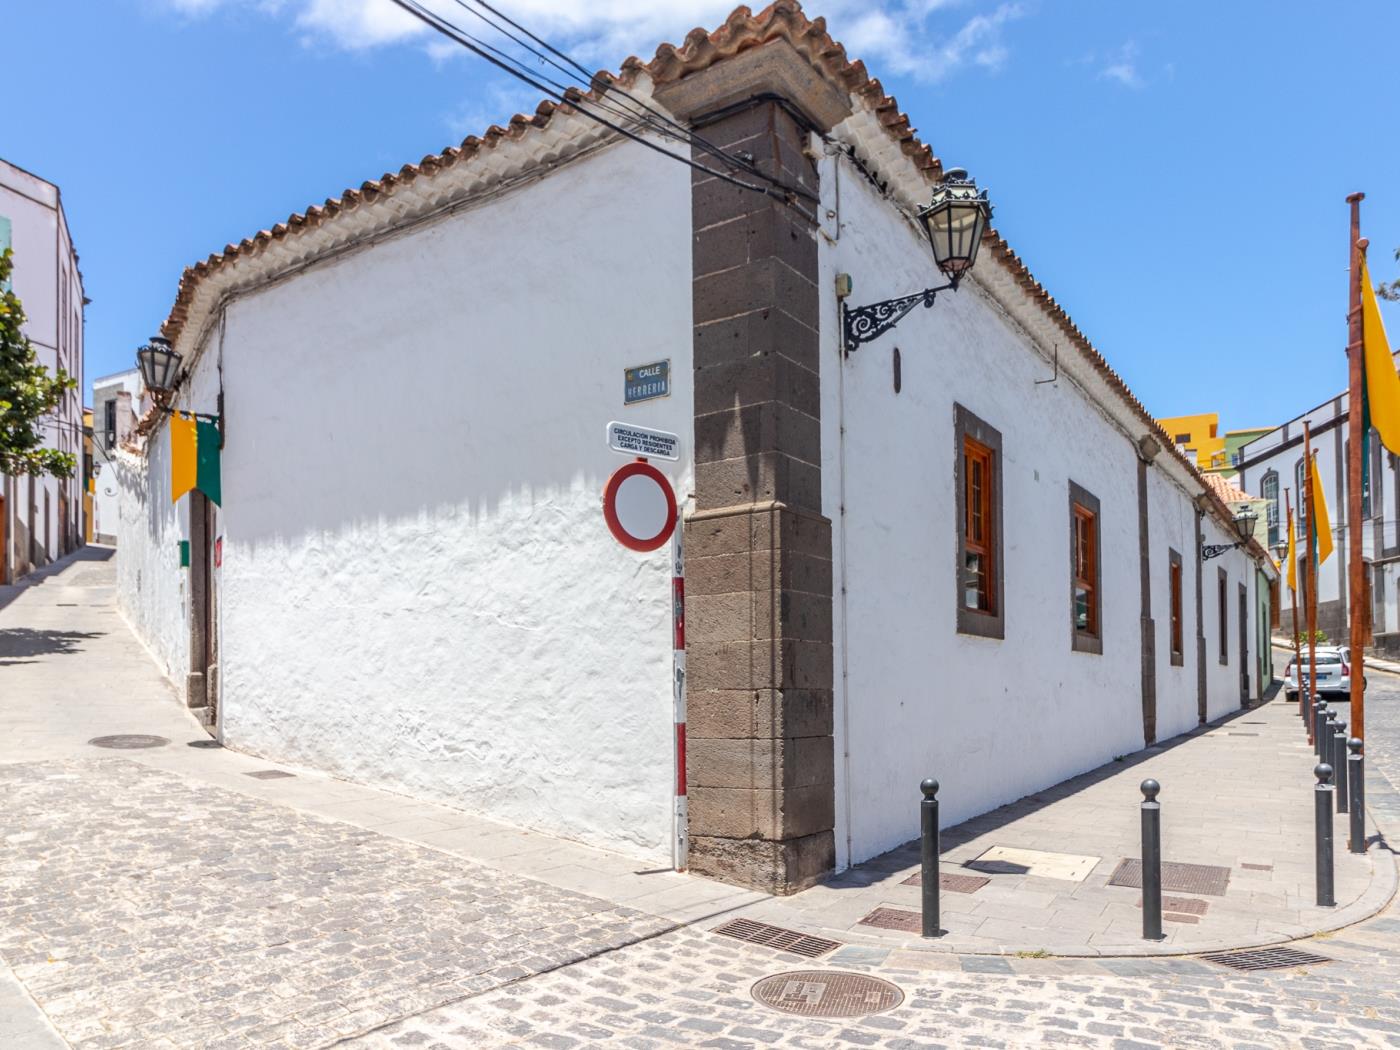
[118,3,1273,892]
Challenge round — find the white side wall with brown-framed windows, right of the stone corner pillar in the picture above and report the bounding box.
[819,151,1260,865]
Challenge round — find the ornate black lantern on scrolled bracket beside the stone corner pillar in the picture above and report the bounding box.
[837,168,991,354]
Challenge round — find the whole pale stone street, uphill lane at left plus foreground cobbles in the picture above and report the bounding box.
[0,561,1400,1050]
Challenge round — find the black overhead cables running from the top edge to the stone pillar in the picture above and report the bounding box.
[393,0,816,203]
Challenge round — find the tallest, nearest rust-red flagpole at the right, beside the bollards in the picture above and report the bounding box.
[1347,193,1371,741]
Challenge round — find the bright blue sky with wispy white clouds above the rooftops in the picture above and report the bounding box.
[0,0,1400,428]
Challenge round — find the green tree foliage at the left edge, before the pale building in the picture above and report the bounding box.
[0,248,77,477]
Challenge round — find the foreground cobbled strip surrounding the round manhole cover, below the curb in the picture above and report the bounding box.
[344,920,1400,1050]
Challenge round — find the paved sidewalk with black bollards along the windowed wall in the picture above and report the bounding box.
[711,699,1396,956]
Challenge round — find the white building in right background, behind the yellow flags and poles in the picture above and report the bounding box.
[1235,383,1400,654]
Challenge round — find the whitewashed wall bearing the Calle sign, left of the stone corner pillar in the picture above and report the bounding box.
[123,137,693,862]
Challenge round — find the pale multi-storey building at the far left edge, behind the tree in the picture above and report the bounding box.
[0,160,84,584]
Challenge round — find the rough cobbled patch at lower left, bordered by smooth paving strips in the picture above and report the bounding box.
[0,759,673,1050]
